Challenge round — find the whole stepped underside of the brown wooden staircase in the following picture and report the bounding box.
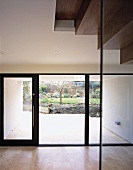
[55,0,133,64]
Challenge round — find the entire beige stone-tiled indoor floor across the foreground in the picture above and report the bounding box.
[0,147,133,170]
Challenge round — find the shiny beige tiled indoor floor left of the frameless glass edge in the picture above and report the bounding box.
[0,147,98,170]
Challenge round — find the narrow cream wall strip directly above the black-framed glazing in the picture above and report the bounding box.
[1,64,100,74]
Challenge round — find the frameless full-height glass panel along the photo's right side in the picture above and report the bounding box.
[102,0,133,170]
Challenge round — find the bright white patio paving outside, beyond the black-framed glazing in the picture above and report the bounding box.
[7,112,128,144]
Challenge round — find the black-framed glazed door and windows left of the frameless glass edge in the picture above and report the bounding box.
[0,74,100,145]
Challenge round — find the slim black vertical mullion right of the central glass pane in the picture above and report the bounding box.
[85,75,89,146]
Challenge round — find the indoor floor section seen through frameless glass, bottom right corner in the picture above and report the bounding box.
[102,146,133,170]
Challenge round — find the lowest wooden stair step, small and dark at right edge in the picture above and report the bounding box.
[120,43,133,64]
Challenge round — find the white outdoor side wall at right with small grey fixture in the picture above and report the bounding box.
[103,76,133,143]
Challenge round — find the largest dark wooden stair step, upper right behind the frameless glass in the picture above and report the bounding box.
[98,0,133,49]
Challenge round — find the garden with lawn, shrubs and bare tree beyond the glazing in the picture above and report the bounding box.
[23,81,100,117]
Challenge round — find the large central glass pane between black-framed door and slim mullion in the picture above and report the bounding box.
[39,75,85,144]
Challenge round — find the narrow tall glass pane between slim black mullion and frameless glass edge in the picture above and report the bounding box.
[89,75,100,144]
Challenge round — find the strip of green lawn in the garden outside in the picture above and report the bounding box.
[40,97,100,104]
